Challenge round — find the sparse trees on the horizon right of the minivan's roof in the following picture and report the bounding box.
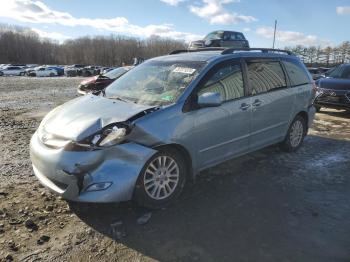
[285,41,350,67]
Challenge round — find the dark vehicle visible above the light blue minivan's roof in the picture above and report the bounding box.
[188,31,249,50]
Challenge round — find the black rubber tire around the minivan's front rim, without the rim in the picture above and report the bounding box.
[133,148,188,209]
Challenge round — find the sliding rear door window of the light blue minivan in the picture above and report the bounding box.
[247,62,287,95]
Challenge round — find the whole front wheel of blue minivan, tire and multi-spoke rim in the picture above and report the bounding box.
[134,149,187,208]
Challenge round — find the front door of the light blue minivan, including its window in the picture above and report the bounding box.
[191,60,251,169]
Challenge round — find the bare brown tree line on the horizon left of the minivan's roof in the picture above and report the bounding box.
[0,25,186,66]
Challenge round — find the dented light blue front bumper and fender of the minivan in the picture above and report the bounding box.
[30,132,156,203]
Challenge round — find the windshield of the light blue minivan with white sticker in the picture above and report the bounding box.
[106,61,206,105]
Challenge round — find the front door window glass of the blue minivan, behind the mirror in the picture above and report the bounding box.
[198,63,244,101]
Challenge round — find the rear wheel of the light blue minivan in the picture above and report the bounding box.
[280,116,307,152]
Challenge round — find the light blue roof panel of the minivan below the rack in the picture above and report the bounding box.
[150,50,298,62]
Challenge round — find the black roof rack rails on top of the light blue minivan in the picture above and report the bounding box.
[169,47,294,55]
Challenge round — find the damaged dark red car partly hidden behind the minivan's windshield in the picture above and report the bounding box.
[78,66,133,95]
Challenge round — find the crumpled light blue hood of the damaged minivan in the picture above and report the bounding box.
[41,95,152,141]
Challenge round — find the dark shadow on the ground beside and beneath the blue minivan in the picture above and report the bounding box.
[71,136,350,261]
